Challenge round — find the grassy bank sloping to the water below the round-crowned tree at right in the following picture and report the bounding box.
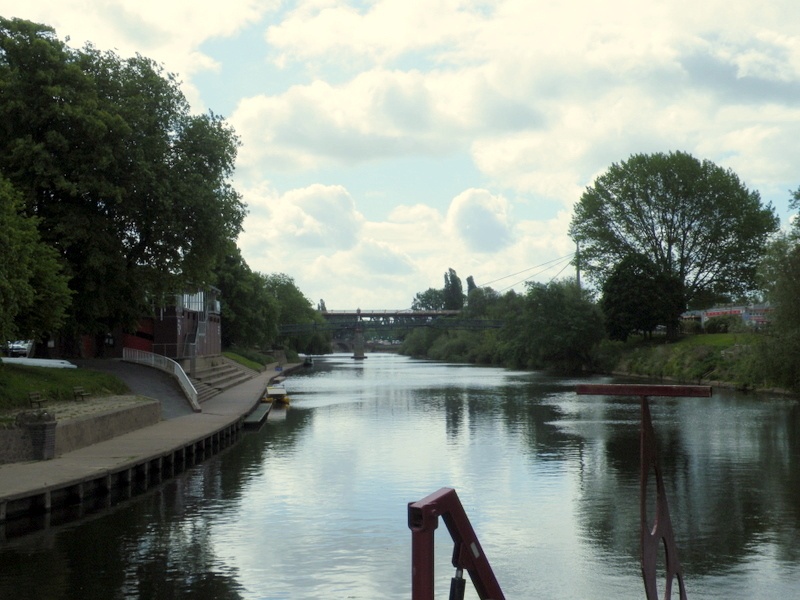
[614,333,775,390]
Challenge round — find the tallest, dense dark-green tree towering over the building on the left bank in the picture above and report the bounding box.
[0,18,245,332]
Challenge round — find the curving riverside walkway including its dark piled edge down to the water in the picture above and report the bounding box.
[0,365,296,523]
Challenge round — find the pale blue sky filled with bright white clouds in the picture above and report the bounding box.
[0,0,800,310]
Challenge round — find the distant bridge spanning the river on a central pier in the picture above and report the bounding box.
[279,308,504,359]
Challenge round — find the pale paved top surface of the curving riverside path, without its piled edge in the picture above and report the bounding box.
[0,365,296,503]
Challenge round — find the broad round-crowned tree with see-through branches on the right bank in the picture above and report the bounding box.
[570,152,779,306]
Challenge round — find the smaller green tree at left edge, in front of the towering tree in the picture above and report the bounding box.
[0,177,70,343]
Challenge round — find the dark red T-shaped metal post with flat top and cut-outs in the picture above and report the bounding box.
[576,384,711,600]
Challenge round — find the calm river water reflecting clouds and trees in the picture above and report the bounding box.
[0,354,800,600]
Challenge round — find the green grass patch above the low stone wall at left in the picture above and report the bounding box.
[0,364,130,410]
